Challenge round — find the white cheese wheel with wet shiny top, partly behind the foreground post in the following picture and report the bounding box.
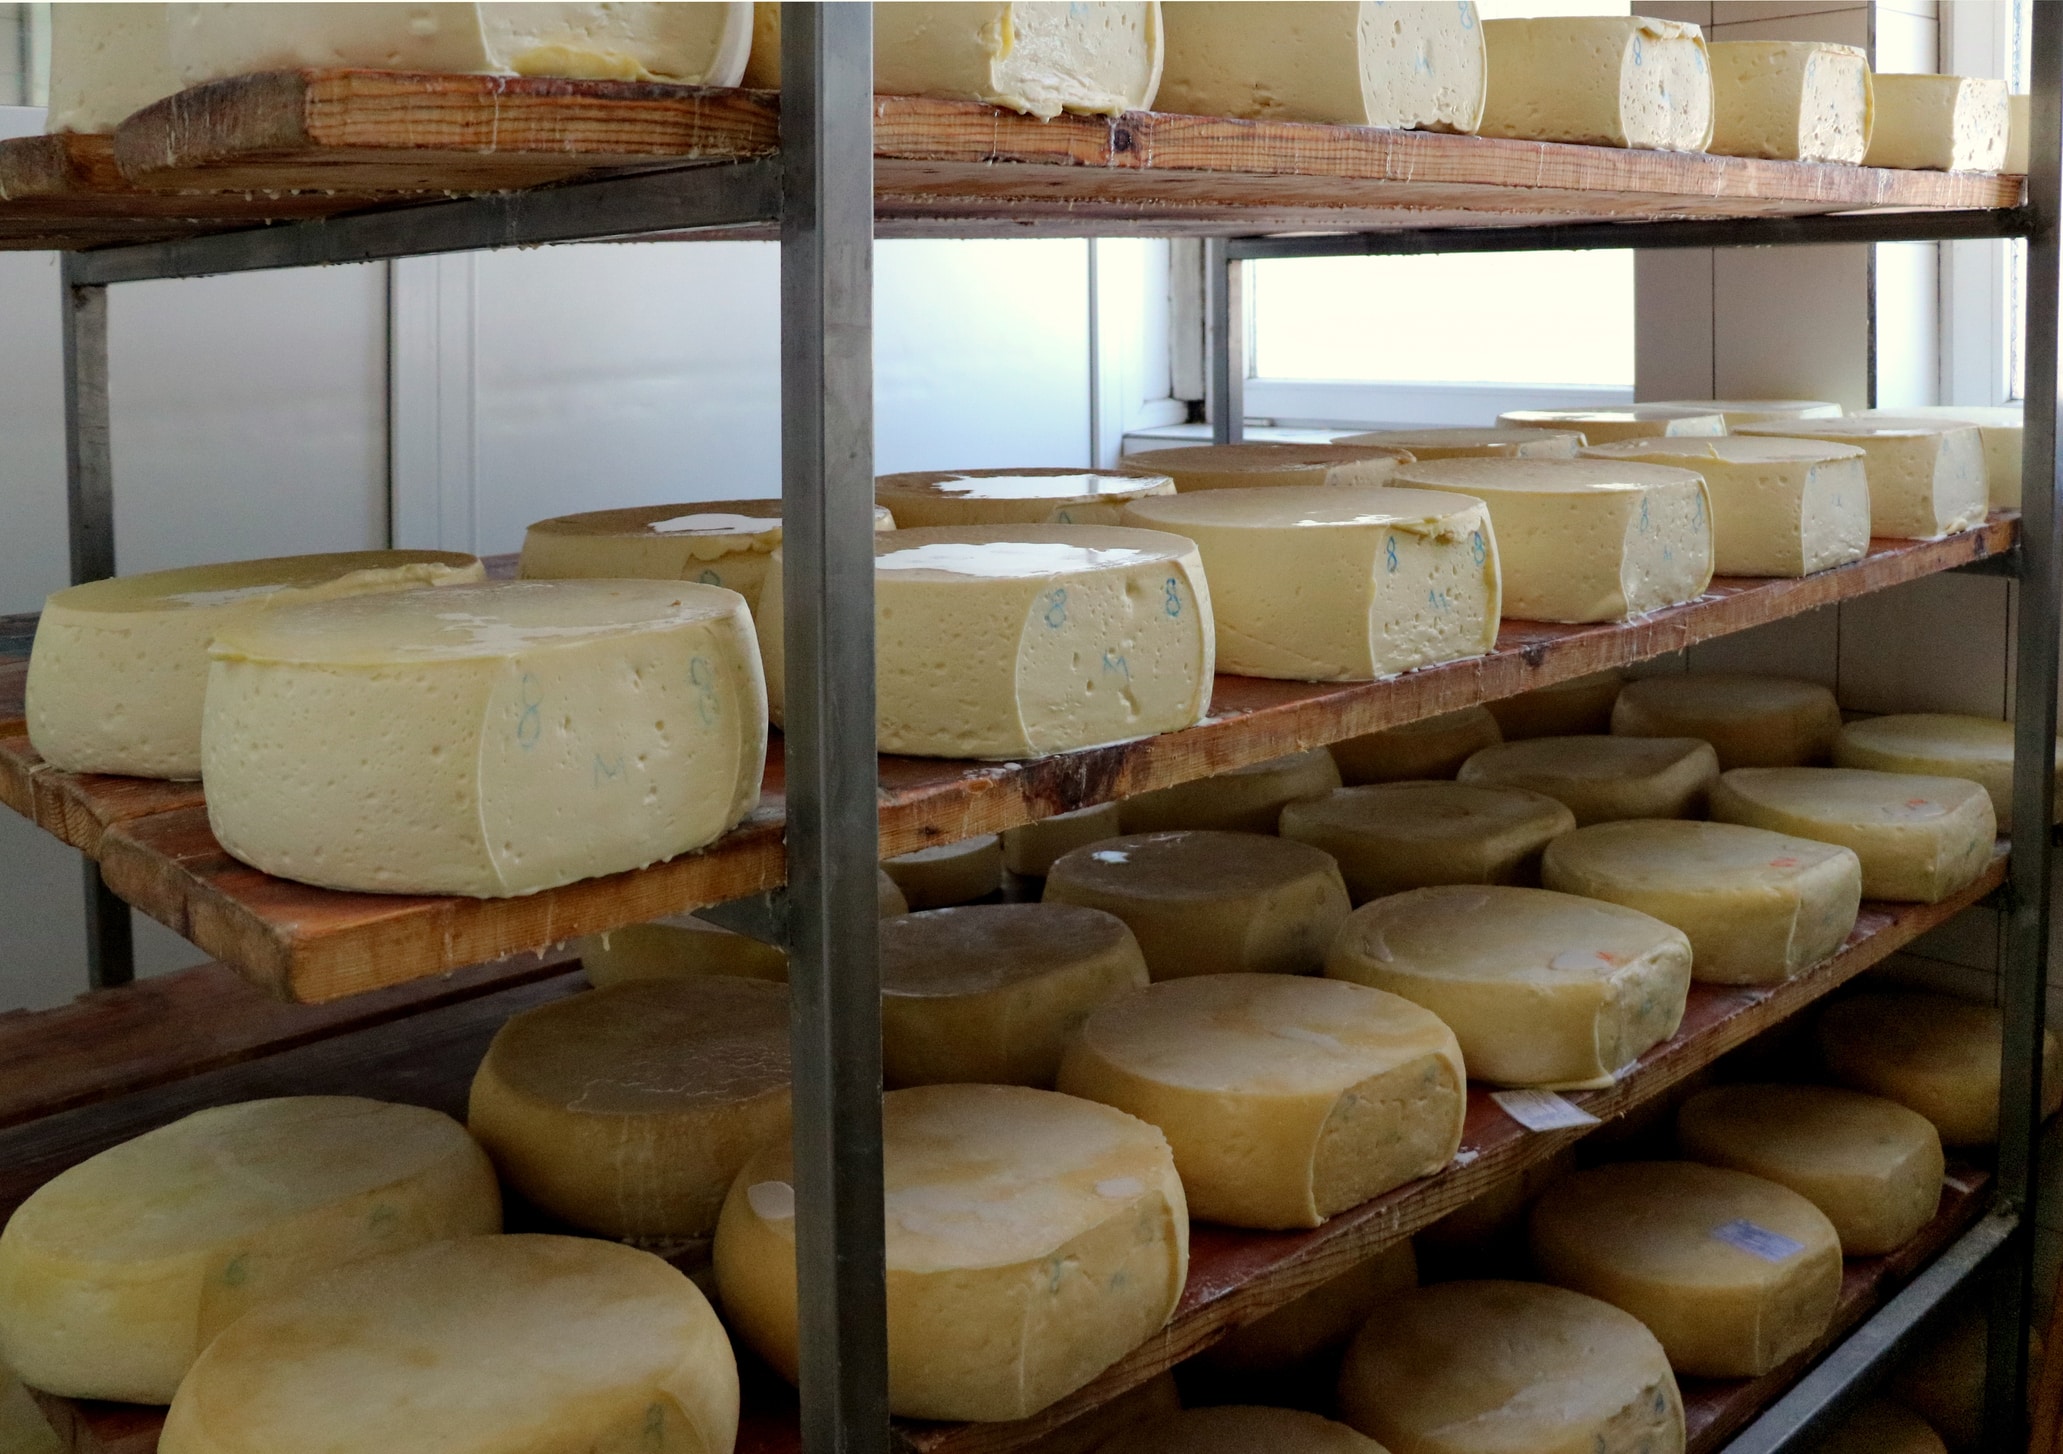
[757,532,1215,759]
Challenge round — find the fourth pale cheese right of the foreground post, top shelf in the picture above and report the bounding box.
[1708,41,1875,165]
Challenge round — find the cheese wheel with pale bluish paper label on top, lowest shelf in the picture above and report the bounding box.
[1531,1161,1840,1378]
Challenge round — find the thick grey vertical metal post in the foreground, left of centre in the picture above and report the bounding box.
[780,0,889,1454]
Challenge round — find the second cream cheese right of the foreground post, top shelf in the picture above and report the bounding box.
[1153,0,1483,132]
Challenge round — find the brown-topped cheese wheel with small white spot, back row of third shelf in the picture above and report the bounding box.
[1046,831,1351,980]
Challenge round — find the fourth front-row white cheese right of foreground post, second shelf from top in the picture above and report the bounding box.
[1584,437,1869,575]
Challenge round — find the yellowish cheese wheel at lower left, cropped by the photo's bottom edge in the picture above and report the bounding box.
[159,1235,739,1454]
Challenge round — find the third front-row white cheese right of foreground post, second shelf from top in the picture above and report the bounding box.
[1397,460,1712,621]
